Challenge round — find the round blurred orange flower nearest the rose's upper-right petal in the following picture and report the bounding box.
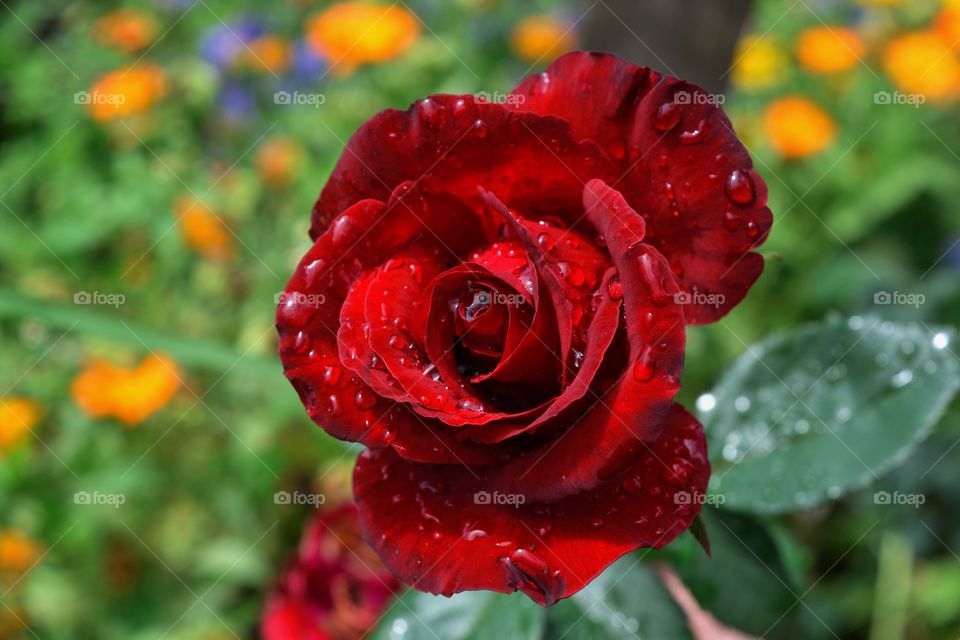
[763,96,837,158]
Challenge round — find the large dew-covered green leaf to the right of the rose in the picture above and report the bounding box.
[701,316,960,513]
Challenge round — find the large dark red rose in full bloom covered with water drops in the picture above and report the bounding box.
[277,53,771,604]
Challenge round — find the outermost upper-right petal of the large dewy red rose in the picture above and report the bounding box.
[510,52,772,324]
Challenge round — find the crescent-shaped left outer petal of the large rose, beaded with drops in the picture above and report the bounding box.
[277,200,497,464]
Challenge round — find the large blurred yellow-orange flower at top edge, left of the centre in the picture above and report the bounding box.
[306,2,420,75]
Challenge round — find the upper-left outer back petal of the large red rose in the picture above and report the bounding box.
[310,95,614,238]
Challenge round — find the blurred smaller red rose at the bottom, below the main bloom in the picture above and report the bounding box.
[260,504,400,640]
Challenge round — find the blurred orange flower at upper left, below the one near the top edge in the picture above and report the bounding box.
[85,62,165,122]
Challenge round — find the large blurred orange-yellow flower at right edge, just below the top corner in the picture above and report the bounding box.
[883,31,960,101]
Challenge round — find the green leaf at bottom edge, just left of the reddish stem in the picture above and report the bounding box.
[545,552,688,640]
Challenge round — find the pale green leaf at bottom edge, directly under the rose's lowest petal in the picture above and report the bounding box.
[372,589,544,640]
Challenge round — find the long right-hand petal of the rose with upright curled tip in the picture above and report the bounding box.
[490,180,684,502]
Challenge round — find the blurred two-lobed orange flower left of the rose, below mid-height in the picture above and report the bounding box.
[70,355,180,427]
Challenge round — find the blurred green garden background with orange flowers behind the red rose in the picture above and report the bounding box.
[0,0,960,640]
